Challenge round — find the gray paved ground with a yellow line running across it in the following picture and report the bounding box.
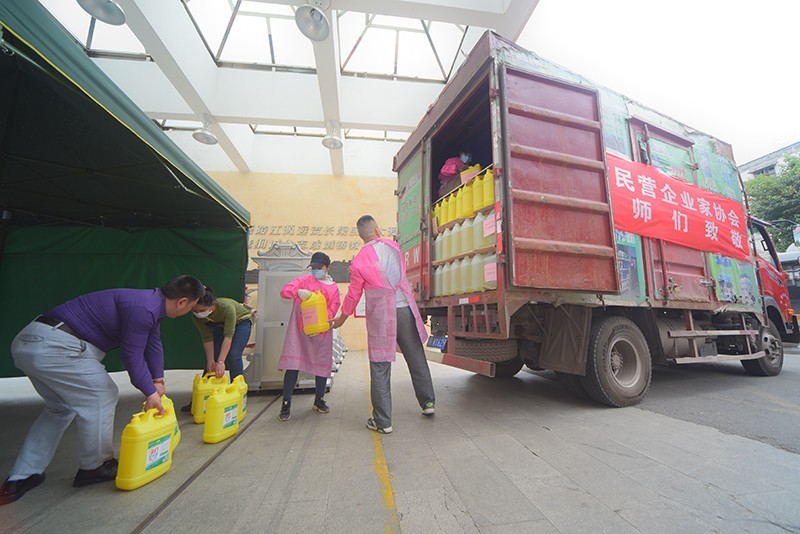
[0,352,800,534]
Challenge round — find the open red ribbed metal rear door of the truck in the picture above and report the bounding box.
[498,65,619,293]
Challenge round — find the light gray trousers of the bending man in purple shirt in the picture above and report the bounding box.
[10,322,119,476]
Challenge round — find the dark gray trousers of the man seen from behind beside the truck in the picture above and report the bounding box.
[369,306,436,428]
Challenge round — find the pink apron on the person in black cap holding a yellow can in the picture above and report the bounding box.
[278,274,339,376]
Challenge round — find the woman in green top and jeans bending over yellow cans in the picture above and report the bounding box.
[192,287,253,381]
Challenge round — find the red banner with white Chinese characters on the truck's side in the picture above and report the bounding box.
[606,154,750,260]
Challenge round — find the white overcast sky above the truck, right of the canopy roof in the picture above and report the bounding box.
[517,0,800,165]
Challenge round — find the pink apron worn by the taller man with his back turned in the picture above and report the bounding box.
[342,238,428,362]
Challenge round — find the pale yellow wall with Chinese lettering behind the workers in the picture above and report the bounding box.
[208,171,397,350]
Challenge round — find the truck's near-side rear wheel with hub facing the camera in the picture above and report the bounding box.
[581,316,652,407]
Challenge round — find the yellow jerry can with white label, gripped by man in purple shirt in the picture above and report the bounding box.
[116,406,178,490]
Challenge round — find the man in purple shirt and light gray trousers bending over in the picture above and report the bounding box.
[0,275,205,505]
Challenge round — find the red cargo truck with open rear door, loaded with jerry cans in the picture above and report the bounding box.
[394,32,800,406]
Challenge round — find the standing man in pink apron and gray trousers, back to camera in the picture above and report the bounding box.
[333,215,436,434]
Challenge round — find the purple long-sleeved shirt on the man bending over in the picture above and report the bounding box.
[45,289,167,395]
